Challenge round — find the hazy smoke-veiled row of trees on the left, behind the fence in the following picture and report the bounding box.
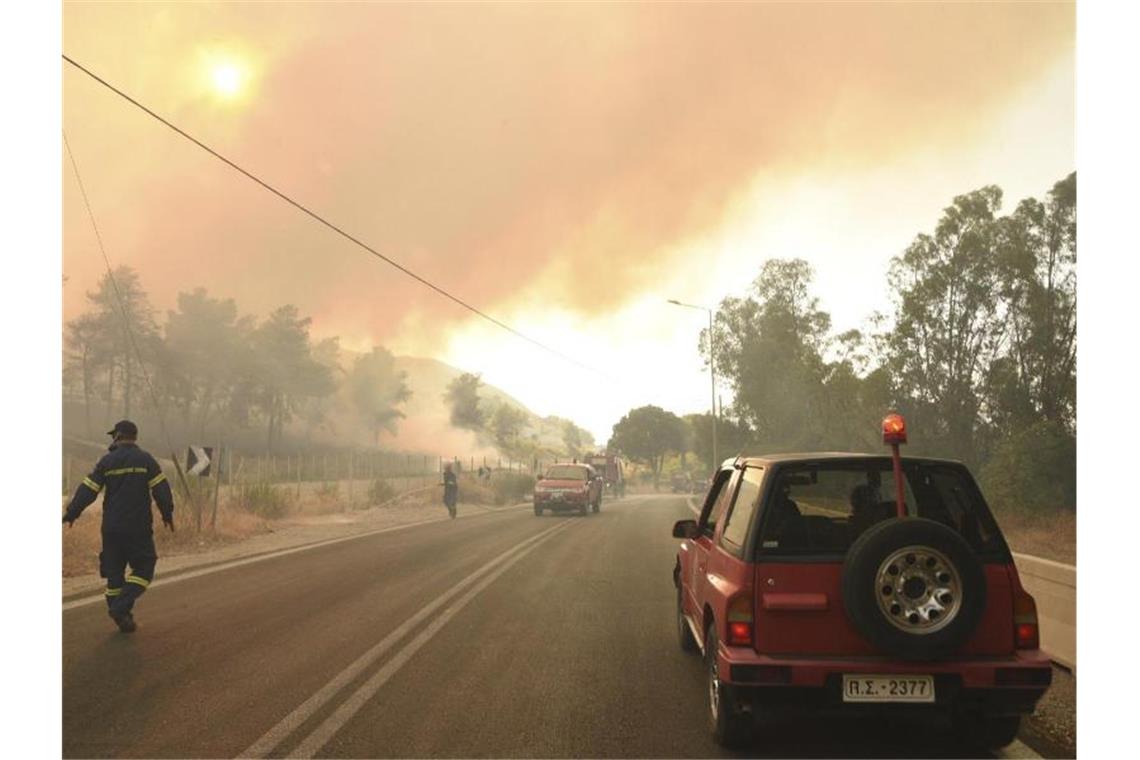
[64,272,412,452]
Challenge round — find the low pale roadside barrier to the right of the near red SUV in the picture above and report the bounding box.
[1013,551,1076,672]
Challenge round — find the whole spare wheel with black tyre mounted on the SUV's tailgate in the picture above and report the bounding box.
[842,517,986,660]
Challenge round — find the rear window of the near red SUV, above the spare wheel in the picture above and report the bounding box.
[759,459,1005,556]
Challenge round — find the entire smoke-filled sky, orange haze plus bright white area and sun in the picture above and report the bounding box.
[63,2,1075,441]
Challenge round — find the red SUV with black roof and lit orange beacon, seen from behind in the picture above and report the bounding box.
[673,418,1052,749]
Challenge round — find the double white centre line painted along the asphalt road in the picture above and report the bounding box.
[238,522,573,758]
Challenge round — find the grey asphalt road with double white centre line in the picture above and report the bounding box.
[63,497,1044,758]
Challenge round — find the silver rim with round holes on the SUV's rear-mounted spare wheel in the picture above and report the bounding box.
[874,546,962,636]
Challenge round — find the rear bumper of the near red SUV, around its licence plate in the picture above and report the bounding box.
[718,645,1052,714]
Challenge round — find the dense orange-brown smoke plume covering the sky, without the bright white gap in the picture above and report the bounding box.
[63,3,1074,353]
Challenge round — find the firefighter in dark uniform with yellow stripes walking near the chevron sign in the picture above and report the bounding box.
[64,419,174,634]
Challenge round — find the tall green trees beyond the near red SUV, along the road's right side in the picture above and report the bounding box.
[610,172,1076,517]
